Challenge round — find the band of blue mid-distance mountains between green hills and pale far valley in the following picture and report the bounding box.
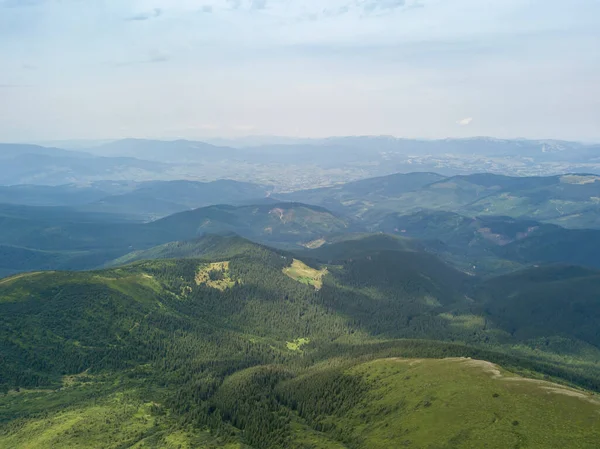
[0,173,600,275]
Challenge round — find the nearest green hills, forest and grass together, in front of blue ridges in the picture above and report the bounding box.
[0,236,600,449]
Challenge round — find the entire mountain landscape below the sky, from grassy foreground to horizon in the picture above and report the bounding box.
[0,137,600,449]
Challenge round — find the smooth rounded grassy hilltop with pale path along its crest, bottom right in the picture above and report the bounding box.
[304,359,600,449]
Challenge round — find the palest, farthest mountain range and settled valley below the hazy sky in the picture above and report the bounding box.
[0,136,600,192]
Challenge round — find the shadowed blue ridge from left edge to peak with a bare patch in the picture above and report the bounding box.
[0,203,353,275]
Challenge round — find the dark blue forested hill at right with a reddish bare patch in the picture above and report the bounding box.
[371,210,600,274]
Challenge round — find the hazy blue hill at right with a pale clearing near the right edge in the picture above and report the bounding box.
[284,173,600,228]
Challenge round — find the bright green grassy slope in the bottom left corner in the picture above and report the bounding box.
[0,382,241,449]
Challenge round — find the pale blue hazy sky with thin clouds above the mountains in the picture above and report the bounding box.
[0,0,600,141]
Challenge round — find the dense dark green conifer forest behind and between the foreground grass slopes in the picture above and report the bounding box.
[0,242,600,448]
